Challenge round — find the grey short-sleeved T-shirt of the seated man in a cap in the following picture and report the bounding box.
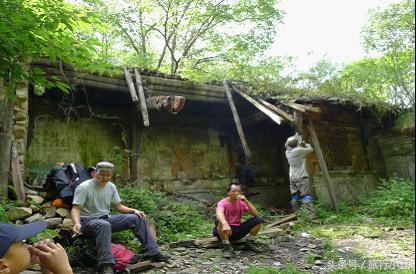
[72,179,121,217]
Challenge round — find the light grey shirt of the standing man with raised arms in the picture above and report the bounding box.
[286,144,313,182]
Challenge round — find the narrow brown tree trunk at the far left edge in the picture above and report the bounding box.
[0,79,13,198]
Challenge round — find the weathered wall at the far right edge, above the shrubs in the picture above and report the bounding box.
[377,134,415,181]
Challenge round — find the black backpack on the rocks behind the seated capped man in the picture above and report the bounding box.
[43,163,92,205]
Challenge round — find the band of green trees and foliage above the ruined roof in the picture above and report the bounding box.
[0,0,415,112]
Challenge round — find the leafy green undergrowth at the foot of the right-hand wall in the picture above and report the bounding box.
[293,179,415,238]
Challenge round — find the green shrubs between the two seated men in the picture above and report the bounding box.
[119,185,214,243]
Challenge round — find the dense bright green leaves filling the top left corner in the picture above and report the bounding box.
[0,0,107,93]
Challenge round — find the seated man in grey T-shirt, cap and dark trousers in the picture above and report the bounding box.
[71,162,169,273]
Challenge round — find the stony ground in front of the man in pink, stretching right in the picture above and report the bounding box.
[25,227,415,274]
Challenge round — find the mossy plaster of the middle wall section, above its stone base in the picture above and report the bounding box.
[137,128,229,181]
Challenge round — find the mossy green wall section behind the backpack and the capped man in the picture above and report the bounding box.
[26,116,124,179]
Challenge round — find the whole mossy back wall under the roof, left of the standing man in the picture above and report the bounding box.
[26,99,289,206]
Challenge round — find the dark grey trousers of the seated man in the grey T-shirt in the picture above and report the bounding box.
[81,214,159,267]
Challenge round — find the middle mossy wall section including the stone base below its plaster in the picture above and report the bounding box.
[137,126,231,197]
